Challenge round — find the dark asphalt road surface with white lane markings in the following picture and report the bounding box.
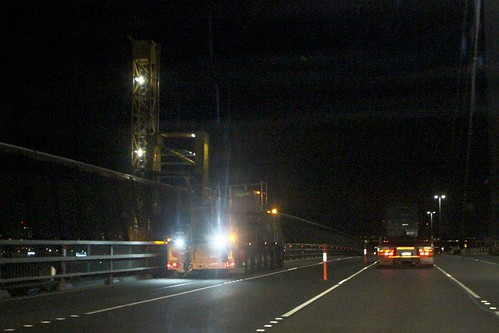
[0,256,499,333]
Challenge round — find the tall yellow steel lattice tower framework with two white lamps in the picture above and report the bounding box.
[129,38,209,240]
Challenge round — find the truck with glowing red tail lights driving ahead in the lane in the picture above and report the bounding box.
[378,200,434,267]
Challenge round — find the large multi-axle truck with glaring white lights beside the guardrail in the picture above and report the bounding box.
[167,184,284,274]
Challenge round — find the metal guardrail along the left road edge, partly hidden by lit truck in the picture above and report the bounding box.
[0,240,361,289]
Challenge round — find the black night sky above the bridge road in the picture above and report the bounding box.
[0,0,488,233]
